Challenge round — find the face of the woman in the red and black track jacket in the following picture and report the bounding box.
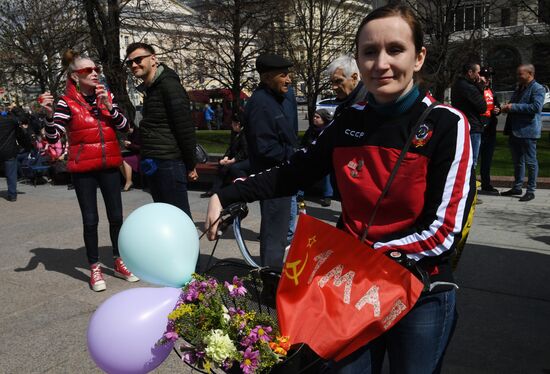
[357,16,426,103]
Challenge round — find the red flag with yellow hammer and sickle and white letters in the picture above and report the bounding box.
[277,214,423,361]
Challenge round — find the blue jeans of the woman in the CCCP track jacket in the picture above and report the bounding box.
[329,289,457,374]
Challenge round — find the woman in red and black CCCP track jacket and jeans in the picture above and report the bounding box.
[206,5,474,373]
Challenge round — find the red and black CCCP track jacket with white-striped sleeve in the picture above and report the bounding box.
[218,95,475,287]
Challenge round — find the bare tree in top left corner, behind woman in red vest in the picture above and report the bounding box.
[0,0,86,101]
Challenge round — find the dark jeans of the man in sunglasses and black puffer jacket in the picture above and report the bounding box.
[148,159,193,219]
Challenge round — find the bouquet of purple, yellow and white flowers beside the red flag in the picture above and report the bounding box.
[159,274,290,374]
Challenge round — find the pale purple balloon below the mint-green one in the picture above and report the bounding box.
[88,287,181,374]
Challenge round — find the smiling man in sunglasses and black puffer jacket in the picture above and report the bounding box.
[126,43,198,217]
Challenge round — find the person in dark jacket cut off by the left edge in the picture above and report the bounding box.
[0,111,30,201]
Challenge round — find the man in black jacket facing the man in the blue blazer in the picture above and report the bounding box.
[451,62,487,168]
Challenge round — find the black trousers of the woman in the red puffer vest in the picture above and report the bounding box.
[72,169,122,264]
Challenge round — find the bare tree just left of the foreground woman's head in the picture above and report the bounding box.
[278,0,370,120]
